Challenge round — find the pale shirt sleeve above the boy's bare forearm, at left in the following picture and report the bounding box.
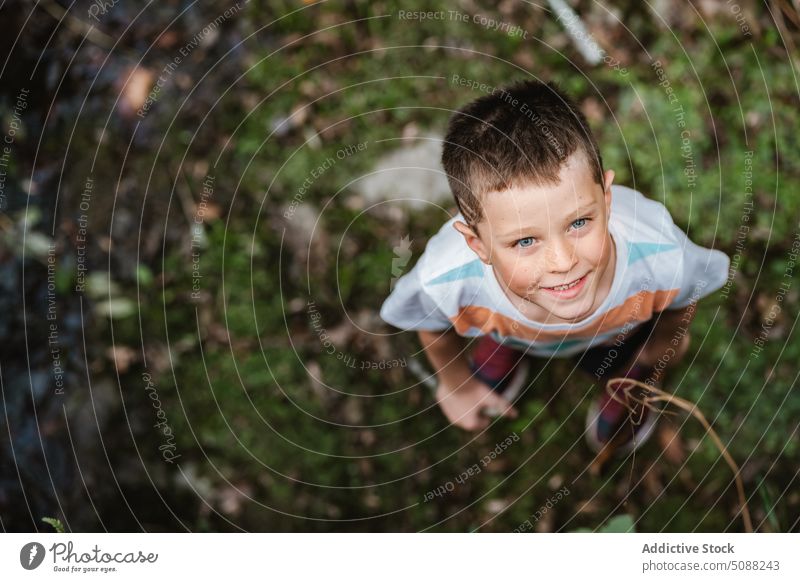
[381,259,453,331]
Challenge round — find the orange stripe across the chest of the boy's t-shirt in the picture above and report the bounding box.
[450,289,679,342]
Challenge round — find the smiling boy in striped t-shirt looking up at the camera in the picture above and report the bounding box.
[381,81,729,450]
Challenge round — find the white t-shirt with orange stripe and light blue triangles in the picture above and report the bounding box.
[381,186,730,357]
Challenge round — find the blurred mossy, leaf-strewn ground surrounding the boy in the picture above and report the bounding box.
[0,0,800,532]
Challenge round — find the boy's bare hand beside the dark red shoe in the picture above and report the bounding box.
[436,378,519,431]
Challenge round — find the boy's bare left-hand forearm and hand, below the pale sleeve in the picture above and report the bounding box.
[417,329,517,430]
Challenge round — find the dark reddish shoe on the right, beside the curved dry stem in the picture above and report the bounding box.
[586,365,658,456]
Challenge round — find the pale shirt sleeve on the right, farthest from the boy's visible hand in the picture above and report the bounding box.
[667,223,730,309]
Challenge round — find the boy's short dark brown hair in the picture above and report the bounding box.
[442,81,603,226]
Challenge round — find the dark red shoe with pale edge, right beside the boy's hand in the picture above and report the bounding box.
[470,335,530,414]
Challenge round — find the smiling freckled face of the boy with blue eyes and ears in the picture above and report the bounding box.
[455,151,614,323]
